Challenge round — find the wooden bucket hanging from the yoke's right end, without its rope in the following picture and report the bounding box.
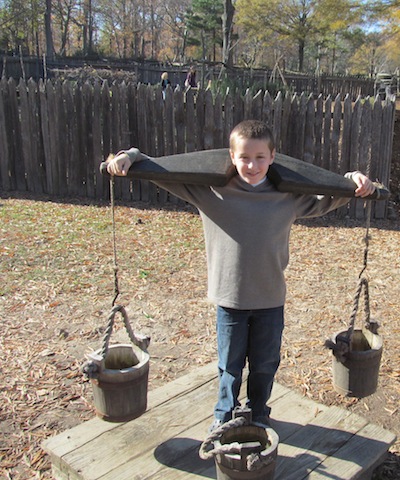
[332,329,383,398]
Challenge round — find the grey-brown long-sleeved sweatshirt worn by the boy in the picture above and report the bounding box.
[126,148,351,310]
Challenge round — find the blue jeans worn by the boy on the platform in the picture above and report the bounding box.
[214,306,284,422]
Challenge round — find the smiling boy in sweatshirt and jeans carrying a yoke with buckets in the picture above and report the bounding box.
[107,120,375,431]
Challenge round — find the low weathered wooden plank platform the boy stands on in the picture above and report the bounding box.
[43,364,395,480]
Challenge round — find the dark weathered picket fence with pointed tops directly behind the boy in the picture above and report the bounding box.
[0,79,395,218]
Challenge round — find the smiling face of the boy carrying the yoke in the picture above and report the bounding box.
[229,137,275,185]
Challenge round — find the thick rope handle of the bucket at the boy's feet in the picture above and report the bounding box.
[199,417,273,471]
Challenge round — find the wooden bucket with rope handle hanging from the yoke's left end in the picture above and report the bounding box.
[83,306,150,422]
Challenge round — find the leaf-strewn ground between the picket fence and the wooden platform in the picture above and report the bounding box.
[0,114,400,480]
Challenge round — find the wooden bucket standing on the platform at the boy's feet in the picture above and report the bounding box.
[214,424,279,480]
